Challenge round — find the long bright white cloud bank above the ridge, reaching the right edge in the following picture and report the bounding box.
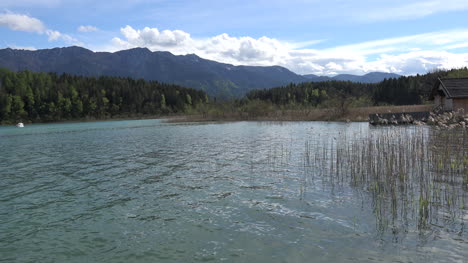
[112,26,468,75]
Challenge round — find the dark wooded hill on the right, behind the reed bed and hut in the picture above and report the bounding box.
[246,68,468,107]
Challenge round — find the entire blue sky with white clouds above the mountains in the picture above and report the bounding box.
[0,0,468,76]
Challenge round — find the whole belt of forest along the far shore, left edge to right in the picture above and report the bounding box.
[0,68,468,124]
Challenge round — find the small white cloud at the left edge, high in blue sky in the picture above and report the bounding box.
[0,13,46,33]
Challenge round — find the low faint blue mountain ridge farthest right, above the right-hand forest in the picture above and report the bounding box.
[303,72,401,83]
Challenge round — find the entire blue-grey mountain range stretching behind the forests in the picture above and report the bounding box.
[0,46,399,97]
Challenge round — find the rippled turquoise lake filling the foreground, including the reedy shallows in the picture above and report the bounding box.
[0,120,468,262]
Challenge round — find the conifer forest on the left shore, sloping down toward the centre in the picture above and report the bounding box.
[0,69,208,123]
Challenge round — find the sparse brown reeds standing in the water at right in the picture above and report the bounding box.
[303,126,468,237]
